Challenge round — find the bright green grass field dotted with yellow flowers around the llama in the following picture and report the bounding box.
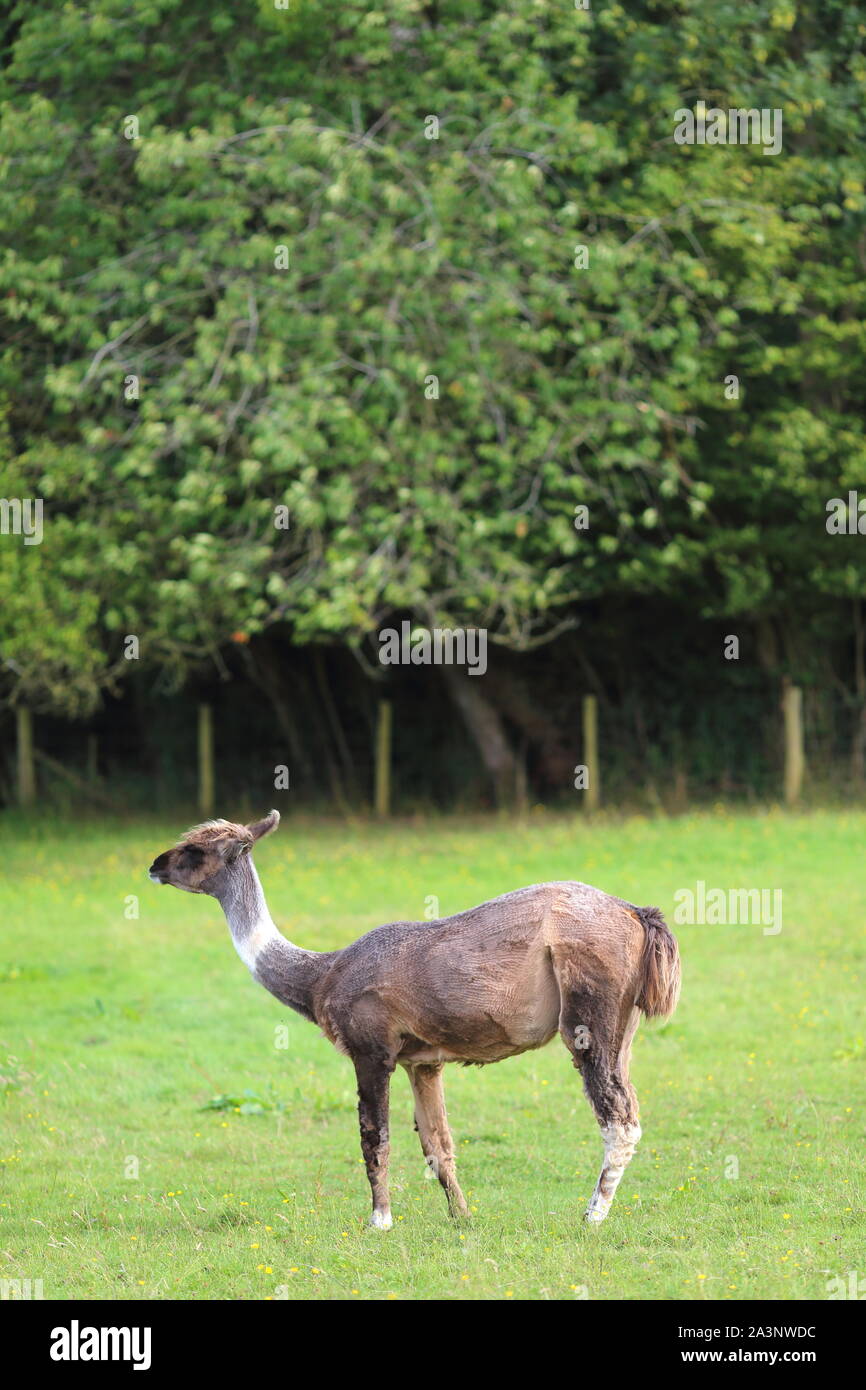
[0,808,866,1300]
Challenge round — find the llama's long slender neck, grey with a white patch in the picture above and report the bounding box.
[217,855,336,1022]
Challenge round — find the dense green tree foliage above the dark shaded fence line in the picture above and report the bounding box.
[0,0,866,713]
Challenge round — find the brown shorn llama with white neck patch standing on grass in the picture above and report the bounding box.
[150,810,680,1230]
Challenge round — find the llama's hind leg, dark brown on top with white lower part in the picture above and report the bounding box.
[560,995,641,1223]
